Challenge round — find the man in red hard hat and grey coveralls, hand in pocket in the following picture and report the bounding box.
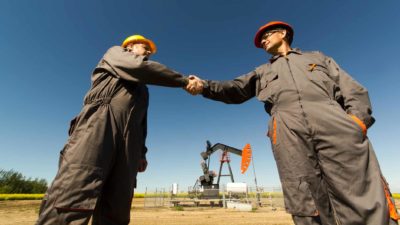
[187,21,398,225]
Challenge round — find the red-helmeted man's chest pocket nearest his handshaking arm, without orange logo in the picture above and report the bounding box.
[257,71,280,103]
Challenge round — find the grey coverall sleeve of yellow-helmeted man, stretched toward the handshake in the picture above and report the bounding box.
[100,46,188,87]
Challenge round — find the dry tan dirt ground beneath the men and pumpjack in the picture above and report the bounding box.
[0,199,400,225]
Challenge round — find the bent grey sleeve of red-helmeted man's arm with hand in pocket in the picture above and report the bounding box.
[326,57,375,128]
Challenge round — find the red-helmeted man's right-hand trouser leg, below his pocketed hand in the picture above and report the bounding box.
[319,138,389,225]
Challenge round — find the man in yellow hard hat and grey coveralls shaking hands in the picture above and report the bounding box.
[37,35,194,225]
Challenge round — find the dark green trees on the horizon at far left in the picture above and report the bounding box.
[0,169,47,194]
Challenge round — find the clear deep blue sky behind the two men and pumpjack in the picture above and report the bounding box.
[0,0,400,192]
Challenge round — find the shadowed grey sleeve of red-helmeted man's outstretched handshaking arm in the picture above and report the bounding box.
[202,71,259,104]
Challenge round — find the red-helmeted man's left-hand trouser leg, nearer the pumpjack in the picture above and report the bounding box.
[269,114,336,225]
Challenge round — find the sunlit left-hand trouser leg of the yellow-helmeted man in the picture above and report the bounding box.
[37,106,116,225]
